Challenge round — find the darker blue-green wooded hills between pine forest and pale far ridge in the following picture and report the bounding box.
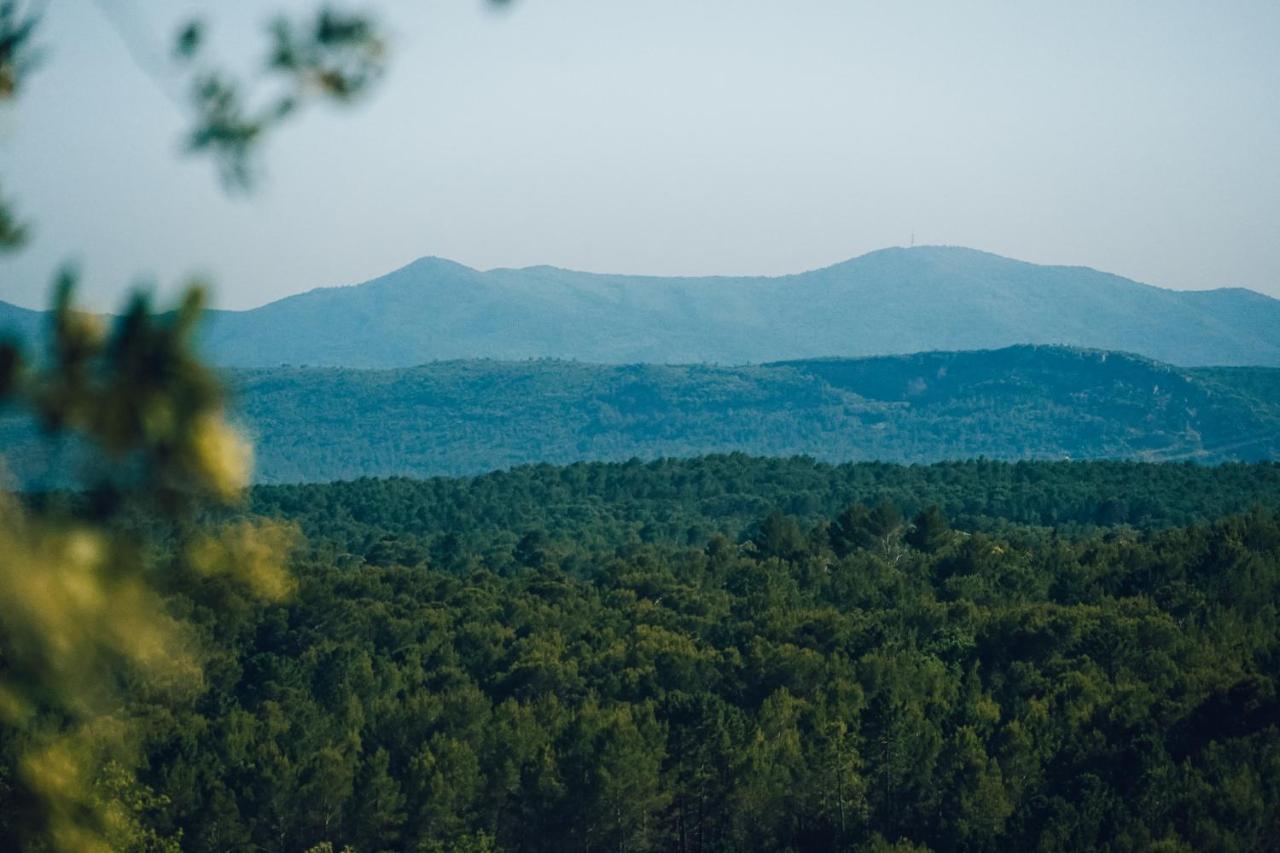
[0,346,1280,484]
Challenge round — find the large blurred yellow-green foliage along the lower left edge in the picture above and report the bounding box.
[0,280,292,850]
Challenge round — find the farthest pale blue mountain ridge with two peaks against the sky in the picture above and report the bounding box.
[0,246,1280,368]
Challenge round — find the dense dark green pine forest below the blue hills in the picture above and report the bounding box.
[0,456,1280,852]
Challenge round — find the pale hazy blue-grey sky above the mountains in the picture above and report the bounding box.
[0,0,1280,309]
